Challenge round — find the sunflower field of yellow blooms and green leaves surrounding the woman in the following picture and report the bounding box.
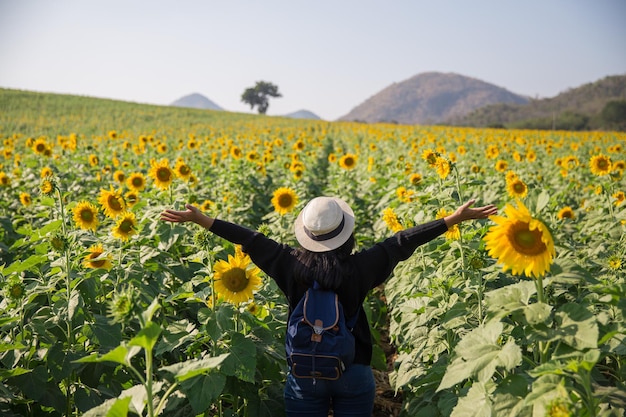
[0,90,626,417]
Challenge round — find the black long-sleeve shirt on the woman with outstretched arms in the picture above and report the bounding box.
[211,219,448,365]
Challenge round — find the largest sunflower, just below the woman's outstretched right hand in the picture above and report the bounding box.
[484,201,556,278]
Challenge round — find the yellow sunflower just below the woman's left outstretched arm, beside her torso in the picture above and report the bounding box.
[213,251,261,305]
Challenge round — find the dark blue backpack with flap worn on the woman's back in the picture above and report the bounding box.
[285,282,358,380]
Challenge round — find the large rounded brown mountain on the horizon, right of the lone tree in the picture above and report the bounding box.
[339,72,530,124]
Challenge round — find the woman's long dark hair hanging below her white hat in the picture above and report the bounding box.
[294,235,355,290]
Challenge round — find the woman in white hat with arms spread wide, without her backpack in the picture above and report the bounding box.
[161,197,497,417]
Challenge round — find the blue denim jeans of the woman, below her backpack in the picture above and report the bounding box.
[284,364,376,417]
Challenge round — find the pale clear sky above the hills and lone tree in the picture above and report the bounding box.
[0,0,626,120]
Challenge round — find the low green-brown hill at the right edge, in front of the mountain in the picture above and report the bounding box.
[446,75,626,129]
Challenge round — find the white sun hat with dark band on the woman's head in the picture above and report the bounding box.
[295,197,354,252]
